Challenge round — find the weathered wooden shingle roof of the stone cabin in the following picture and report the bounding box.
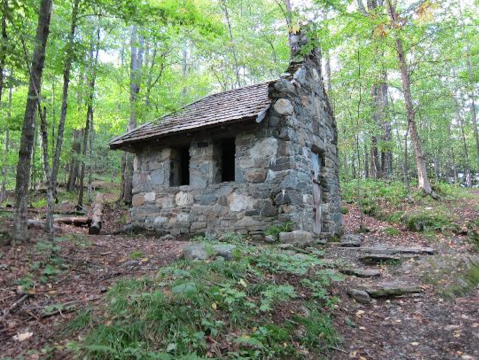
[110,81,271,149]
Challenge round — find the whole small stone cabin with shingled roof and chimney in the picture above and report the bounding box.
[110,28,342,236]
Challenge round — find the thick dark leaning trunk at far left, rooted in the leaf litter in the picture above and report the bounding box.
[13,0,52,243]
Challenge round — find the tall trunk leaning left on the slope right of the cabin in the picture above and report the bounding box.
[388,0,437,198]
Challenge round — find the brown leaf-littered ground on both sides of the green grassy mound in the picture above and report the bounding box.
[0,190,479,360]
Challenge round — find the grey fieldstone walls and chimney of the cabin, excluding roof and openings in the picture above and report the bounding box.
[124,26,342,235]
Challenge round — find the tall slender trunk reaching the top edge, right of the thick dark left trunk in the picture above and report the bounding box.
[52,0,80,197]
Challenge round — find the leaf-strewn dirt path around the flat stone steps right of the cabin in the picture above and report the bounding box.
[327,208,479,360]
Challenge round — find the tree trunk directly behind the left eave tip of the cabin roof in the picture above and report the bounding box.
[121,25,144,205]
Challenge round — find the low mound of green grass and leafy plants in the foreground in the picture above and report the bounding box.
[72,248,338,359]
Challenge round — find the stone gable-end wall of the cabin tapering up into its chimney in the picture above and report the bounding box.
[268,23,342,236]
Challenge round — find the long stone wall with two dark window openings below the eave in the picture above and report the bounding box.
[131,123,292,235]
